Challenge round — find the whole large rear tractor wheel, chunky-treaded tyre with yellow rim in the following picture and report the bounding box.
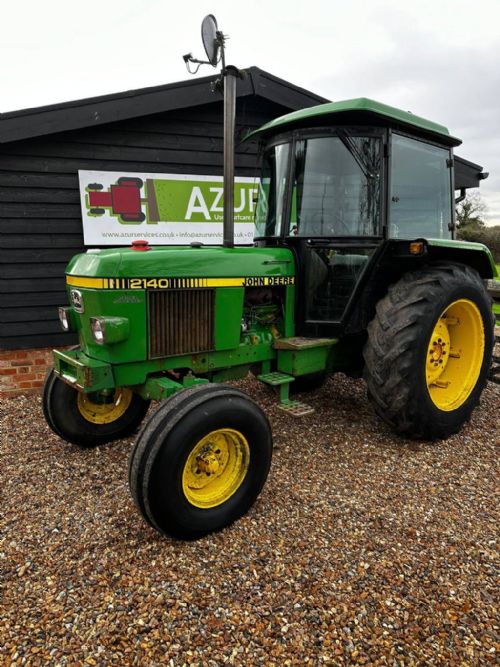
[363,263,494,440]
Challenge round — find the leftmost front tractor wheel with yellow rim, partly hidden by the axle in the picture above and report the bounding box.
[42,370,150,447]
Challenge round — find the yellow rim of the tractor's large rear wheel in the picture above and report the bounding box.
[425,299,484,412]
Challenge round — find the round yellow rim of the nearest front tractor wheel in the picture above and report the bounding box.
[182,428,250,509]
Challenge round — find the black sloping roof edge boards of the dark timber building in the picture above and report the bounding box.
[0,67,328,144]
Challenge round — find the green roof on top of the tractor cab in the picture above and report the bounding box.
[247,97,462,146]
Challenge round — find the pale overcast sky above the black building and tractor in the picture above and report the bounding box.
[0,0,500,224]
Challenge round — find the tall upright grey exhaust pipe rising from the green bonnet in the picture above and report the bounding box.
[222,65,239,248]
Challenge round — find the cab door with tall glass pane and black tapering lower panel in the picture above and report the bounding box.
[285,128,383,336]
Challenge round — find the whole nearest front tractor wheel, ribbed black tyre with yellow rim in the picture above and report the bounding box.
[129,384,272,539]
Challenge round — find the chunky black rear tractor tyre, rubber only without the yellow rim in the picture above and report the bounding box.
[363,262,494,440]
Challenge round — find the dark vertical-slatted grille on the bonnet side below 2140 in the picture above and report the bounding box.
[148,289,215,359]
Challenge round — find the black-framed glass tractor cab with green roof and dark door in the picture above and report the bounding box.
[251,98,487,336]
